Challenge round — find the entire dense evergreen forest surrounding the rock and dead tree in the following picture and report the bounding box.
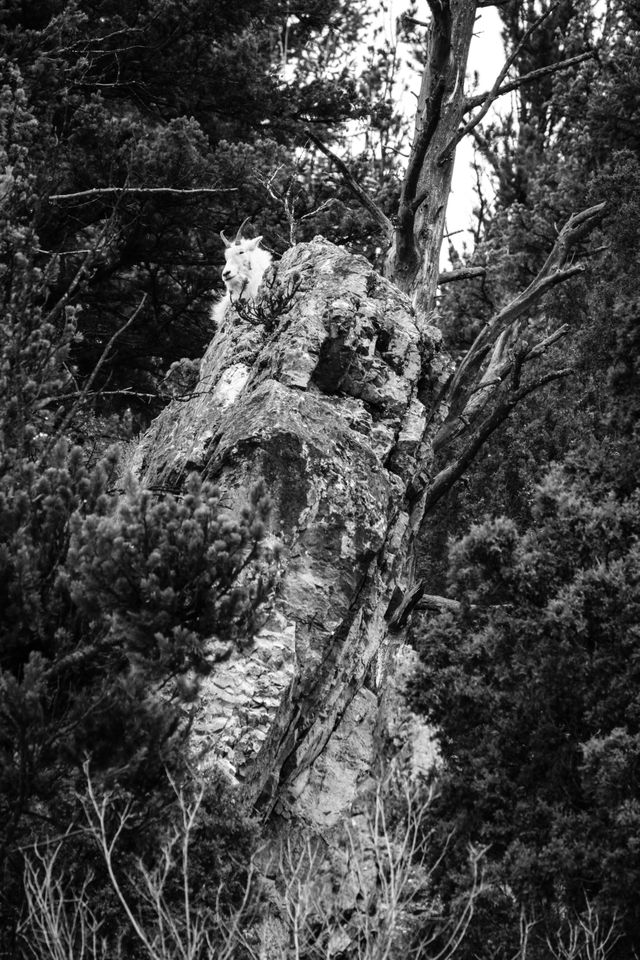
[0,0,640,960]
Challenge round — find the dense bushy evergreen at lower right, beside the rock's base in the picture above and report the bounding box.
[412,468,640,956]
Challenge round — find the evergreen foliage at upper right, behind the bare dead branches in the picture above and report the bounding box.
[424,2,640,590]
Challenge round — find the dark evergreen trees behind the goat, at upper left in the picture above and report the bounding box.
[0,0,404,428]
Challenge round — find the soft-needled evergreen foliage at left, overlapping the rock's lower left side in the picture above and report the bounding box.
[0,97,274,956]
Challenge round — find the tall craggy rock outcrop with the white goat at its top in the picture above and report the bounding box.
[134,238,439,829]
